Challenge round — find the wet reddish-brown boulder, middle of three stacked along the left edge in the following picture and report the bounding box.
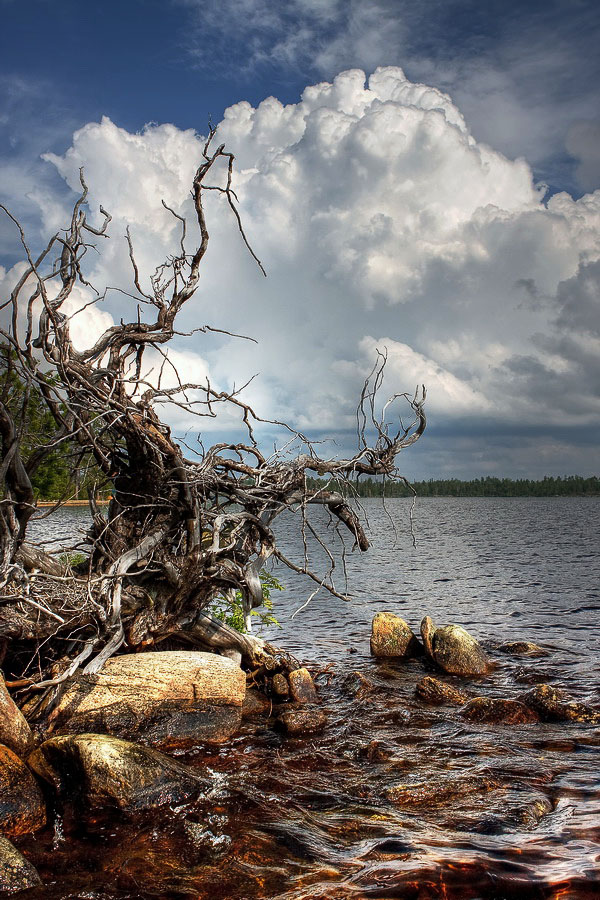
[0,745,46,837]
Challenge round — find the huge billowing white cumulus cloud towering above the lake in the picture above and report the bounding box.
[8,68,600,475]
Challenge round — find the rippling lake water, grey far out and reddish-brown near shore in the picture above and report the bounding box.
[19,498,600,900]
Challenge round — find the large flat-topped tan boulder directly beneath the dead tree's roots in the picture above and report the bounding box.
[45,651,246,750]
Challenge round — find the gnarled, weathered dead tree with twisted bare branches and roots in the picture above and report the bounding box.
[0,133,425,712]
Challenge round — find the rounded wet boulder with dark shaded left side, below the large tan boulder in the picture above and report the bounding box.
[29,734,206,813]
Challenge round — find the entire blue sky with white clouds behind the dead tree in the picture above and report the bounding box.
[0,0,600,479]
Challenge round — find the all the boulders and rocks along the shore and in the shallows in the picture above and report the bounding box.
[0,612,600,895]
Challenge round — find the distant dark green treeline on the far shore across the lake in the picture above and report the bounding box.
[307,475,600,497]
